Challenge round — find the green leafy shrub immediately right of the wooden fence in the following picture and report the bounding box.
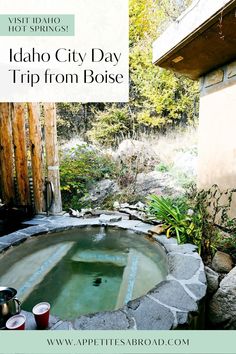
[60,144,115,209]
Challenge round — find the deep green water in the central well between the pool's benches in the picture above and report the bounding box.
[23,248,124,319]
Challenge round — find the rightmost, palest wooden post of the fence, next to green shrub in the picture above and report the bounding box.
[44,103,62,214]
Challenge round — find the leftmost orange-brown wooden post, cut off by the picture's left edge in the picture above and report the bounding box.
[0,103,15,203]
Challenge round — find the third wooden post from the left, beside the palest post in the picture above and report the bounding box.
[28,103,44,213]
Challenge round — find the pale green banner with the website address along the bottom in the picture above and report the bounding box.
[0,331,236,354]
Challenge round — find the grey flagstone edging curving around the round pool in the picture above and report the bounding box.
[0,216,207,330]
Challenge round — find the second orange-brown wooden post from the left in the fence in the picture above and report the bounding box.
[12,103,30,205]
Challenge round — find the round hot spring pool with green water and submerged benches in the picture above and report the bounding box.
[0,227,167,320]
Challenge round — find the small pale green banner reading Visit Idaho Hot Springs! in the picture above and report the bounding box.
[0,14,75,36]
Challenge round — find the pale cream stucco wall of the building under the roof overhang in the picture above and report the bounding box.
[198,62,236,216]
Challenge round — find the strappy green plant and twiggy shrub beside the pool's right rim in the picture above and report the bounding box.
[148,185,236,260]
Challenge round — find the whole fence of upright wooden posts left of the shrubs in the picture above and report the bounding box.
[0,103,62,214]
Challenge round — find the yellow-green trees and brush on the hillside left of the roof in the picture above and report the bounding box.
[57,0,198,147]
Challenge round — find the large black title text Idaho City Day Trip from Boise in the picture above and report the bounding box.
[9,48,124,87]
